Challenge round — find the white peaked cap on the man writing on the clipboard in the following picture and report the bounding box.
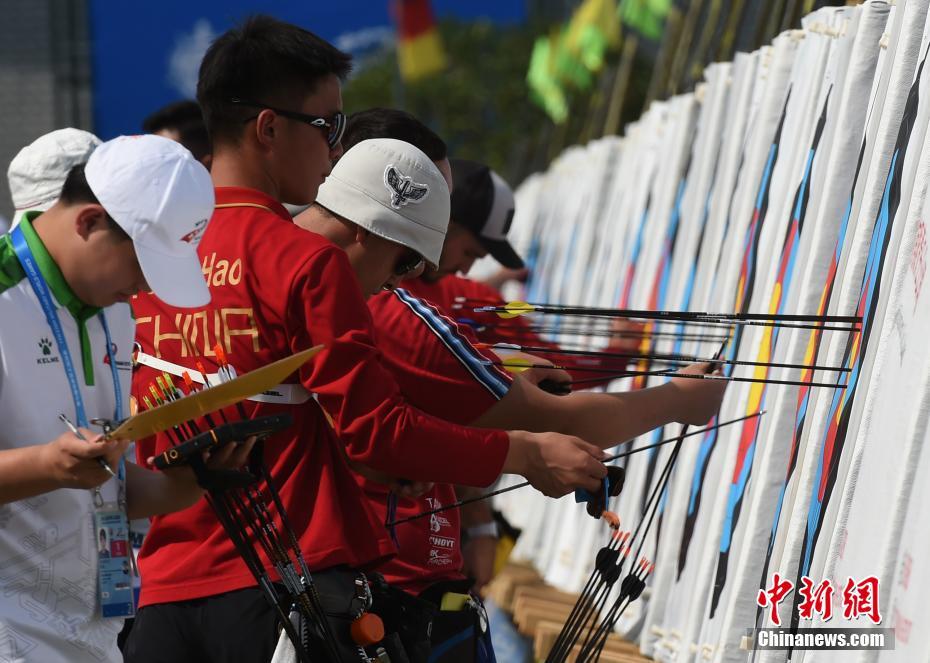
[84,134,215,307]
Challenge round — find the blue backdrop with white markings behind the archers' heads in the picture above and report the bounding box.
[90,0,526,140]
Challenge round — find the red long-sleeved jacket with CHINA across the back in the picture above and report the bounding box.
[133,188,508,606]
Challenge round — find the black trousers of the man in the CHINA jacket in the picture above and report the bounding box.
[123,587,278,663]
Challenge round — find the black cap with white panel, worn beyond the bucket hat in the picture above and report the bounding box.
[450,159,523,269]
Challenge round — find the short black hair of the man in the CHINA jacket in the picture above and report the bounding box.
[197,15,352,144]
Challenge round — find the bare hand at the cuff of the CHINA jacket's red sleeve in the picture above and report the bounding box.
[503,431,607,497]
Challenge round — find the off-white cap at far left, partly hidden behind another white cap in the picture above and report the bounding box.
[6,127,100,225]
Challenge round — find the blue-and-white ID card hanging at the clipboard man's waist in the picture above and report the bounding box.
[94,509,135,618]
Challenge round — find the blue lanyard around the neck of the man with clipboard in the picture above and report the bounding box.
[10,226,123,428]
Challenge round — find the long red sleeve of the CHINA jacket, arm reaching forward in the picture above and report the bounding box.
[286,247,508,486]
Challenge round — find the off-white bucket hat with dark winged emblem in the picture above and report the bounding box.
[316,138,450,267]
